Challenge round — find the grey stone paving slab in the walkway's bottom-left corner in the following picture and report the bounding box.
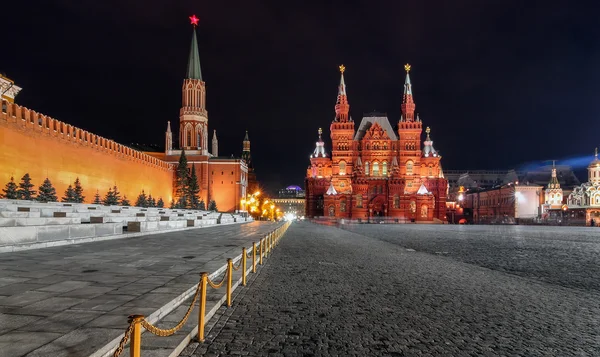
[0,331,62,357]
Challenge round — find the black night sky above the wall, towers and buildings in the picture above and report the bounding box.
[0,0,600,192]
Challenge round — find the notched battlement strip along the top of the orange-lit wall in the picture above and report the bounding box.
[0,100,173,171]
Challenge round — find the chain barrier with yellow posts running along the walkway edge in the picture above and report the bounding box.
[113,222,291,357]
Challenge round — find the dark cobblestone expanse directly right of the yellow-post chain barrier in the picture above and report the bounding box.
[186,223,600,357]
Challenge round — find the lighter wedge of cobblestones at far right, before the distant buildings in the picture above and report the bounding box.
[342,224,600,292]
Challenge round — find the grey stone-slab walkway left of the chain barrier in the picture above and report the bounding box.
[0,222,275,357]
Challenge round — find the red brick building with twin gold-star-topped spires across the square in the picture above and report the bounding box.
[305,65,447,222]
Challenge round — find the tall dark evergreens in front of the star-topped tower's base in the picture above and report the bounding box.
[171,150,217,211]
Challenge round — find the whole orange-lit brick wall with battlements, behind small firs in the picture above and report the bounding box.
[0,101,173,204]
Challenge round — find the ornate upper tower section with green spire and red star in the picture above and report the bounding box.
[179,16,208,155]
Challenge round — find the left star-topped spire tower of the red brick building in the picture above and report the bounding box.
[329,65,354,184]
